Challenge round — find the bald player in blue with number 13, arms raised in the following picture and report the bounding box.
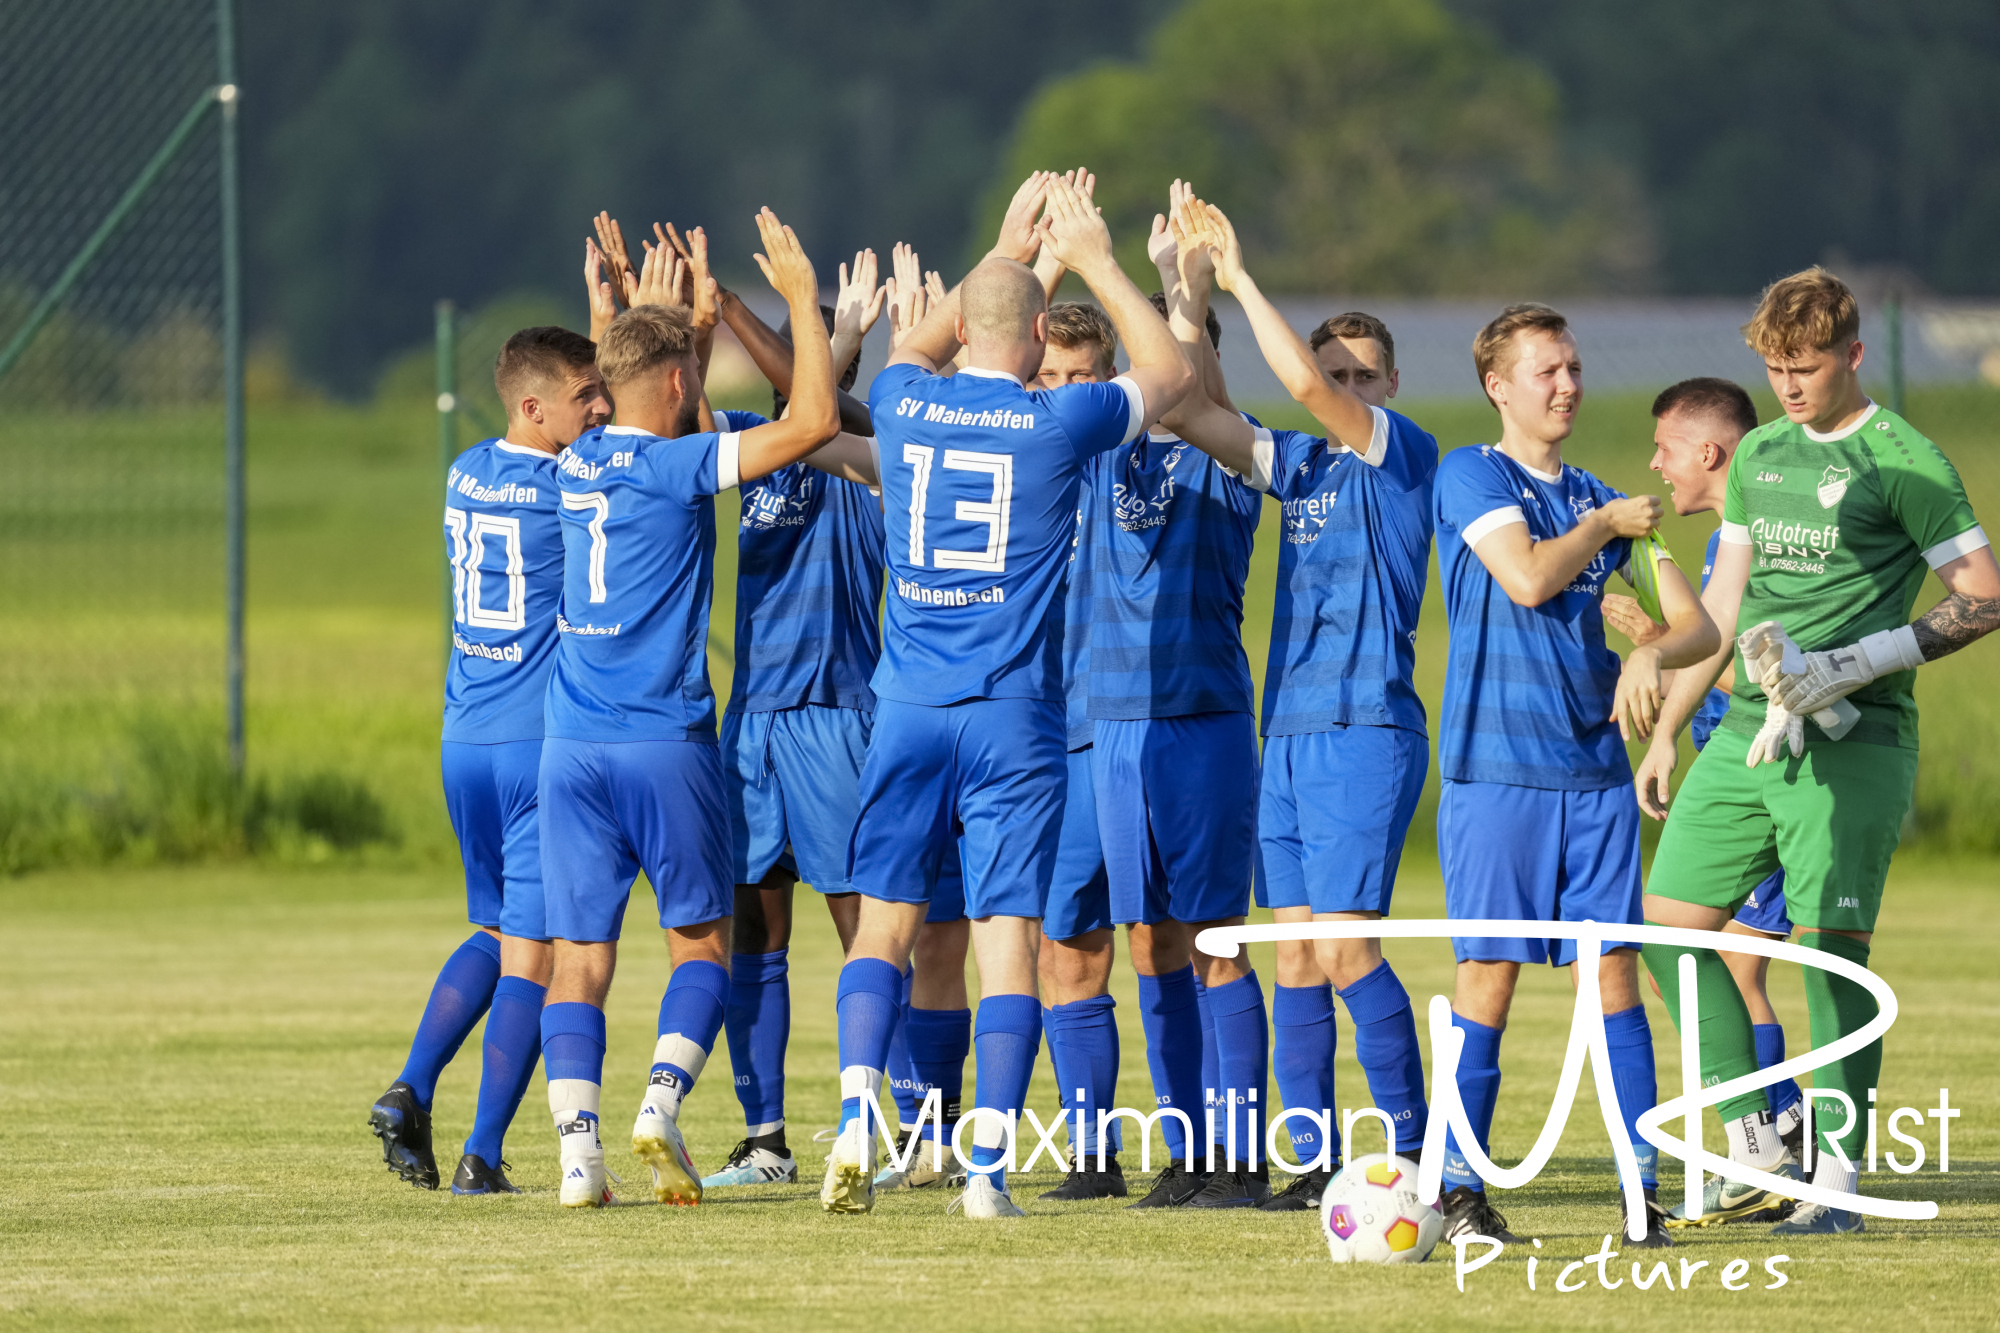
[820,172,1194,1219]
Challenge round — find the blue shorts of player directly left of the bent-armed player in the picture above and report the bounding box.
[1256,727,1430,917]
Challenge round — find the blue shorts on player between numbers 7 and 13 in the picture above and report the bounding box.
[722,705,874,893]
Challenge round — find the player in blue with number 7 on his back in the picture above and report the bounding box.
[542,208,840,1207]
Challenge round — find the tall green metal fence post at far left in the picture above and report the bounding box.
[216,0,248,777]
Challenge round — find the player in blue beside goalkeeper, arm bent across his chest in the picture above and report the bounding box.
[1436,304,1720,1245]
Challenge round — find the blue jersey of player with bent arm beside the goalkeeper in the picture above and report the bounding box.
[1438,444,1632,791]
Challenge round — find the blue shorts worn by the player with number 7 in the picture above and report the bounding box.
[542,737,736,943]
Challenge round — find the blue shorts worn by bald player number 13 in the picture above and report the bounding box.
[848,699,1070,919]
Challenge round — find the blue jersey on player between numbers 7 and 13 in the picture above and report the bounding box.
[716,412,882,713]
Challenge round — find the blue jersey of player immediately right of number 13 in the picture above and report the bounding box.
[1078,430,1264,721]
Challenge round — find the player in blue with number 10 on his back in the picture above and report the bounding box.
[368,326,612,1195]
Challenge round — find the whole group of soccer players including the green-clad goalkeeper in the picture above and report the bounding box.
[370,172,2000,1245]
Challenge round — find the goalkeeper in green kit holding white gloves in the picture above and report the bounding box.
[1634,268,2000,1235]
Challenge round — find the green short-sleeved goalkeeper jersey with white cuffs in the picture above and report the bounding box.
[1722,394,1986,747]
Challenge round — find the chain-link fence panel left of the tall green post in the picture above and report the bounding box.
[0,0,242,868]
